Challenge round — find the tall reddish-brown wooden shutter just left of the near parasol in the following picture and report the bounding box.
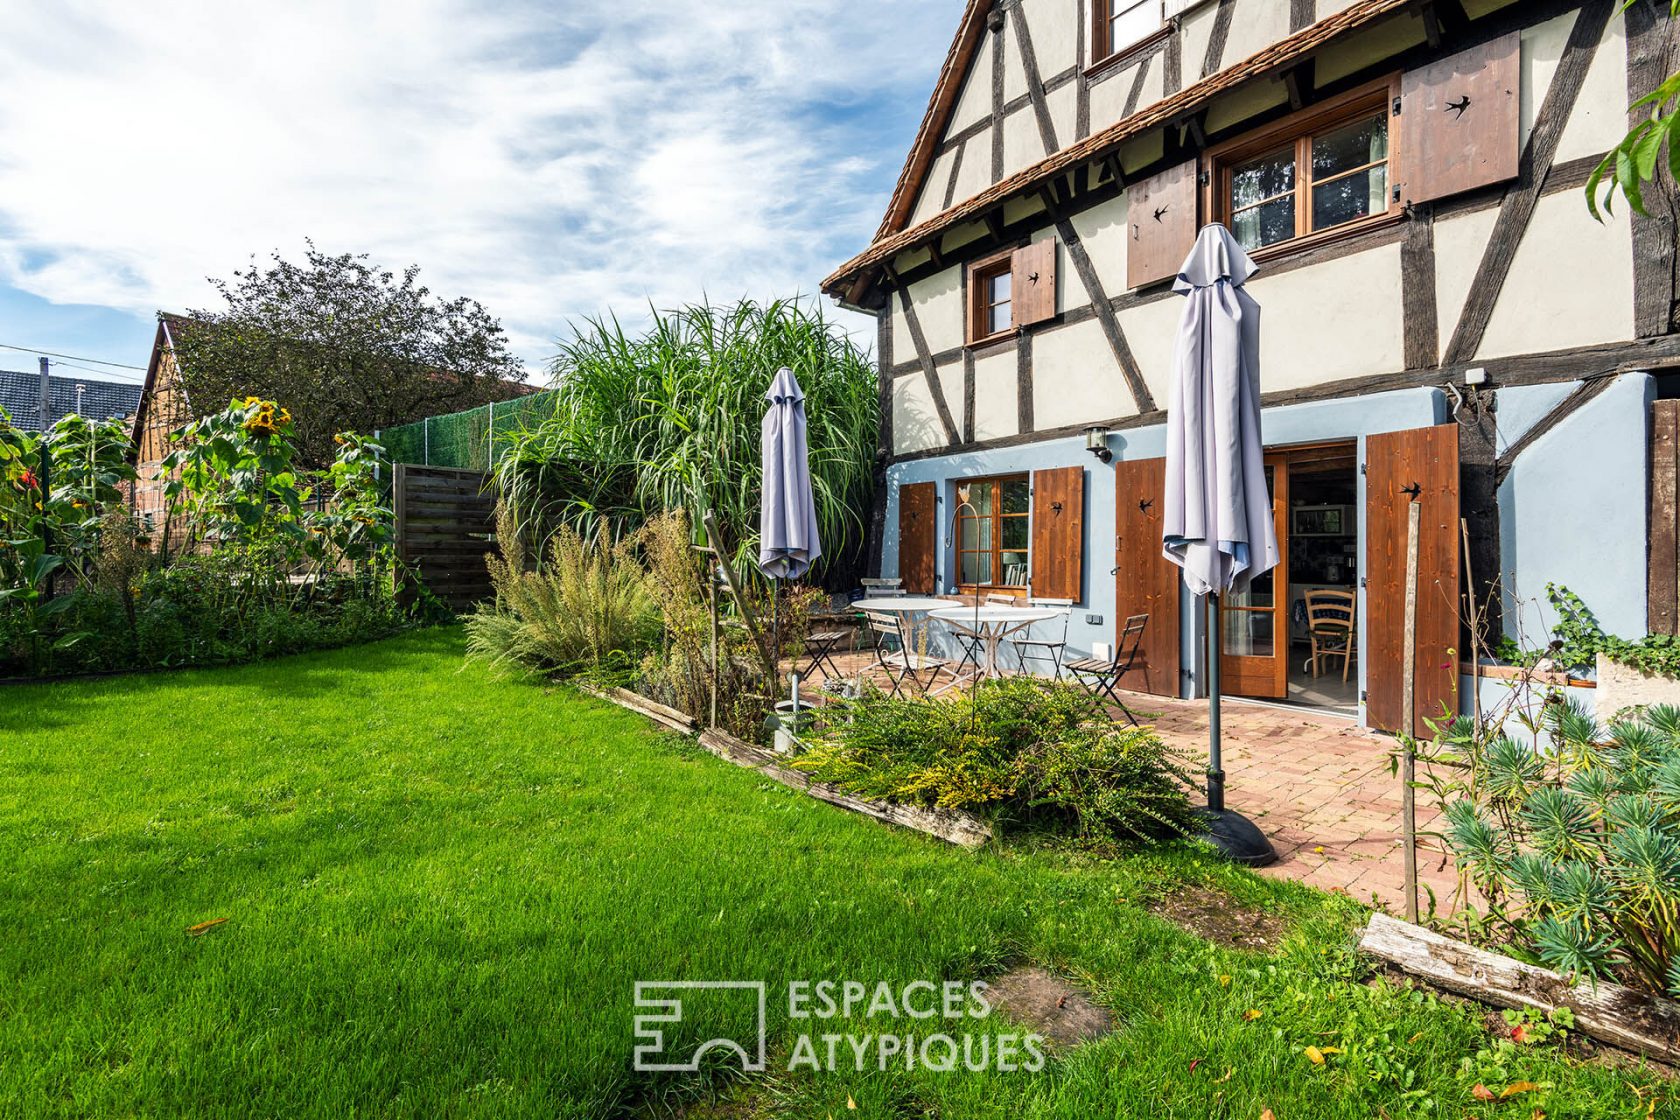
[1114,458,1179,697]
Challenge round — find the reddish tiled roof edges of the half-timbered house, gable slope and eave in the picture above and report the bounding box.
[822,0,1411,301]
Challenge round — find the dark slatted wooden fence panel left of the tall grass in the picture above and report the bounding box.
[391,463,496,613]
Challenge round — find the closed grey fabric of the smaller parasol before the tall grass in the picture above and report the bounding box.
[758,366,823,579]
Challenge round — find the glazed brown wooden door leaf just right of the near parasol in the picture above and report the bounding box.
[1220,455,1289,700]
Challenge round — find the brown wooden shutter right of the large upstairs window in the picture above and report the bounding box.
[1394,32,1520,201]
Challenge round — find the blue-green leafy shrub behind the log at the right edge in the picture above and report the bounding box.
[1443,700,1680,996]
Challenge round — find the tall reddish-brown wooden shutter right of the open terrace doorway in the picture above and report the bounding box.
[1362,423,1460,735]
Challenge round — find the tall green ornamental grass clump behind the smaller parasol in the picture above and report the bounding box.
[497,301,880,586]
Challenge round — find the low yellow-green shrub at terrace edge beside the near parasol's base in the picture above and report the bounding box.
[791,678,1193,840]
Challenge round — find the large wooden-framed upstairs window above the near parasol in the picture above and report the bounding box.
[1206,74,1401,255]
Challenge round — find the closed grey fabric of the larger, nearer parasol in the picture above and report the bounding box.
[1163,223,1277,594]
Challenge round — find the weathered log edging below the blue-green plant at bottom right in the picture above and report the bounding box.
[1359,913,1680,1061]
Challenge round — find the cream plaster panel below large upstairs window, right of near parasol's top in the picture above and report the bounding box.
[1248,245,1404,393]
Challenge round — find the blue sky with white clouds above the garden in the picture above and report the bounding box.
[0,0,963,379]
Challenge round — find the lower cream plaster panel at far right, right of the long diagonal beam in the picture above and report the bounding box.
[1477,190,1633,358]
